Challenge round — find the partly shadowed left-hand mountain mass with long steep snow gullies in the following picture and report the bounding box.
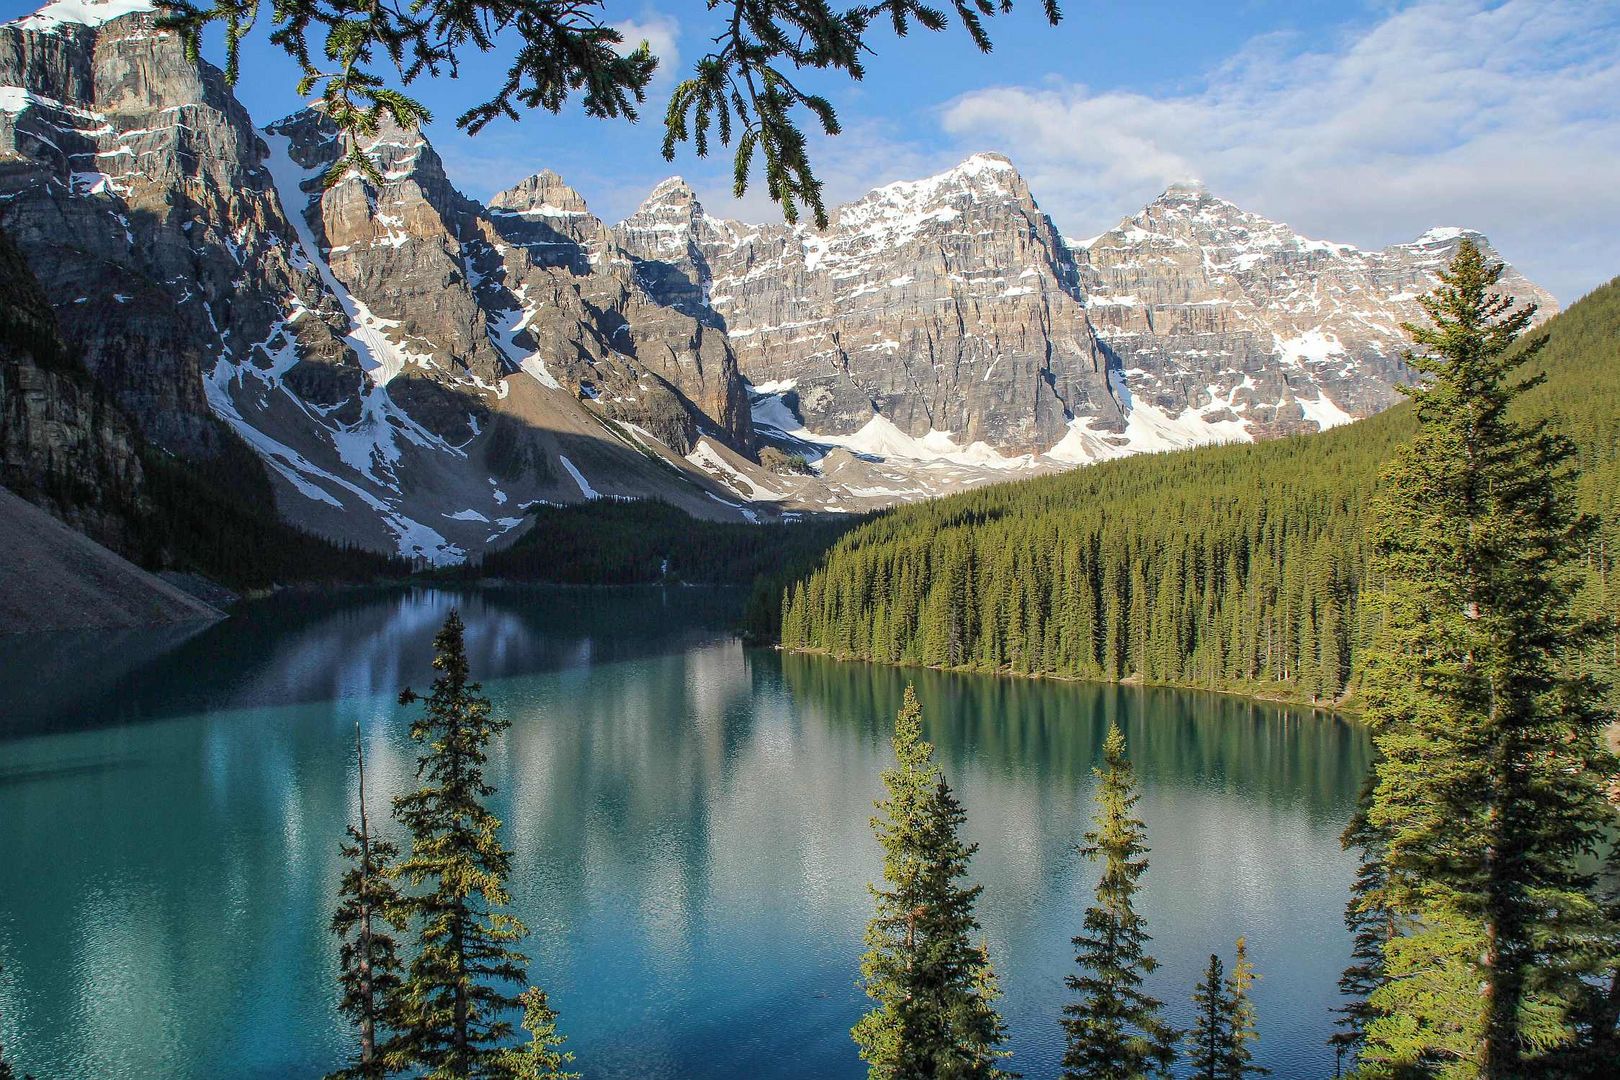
[0,0,764,562]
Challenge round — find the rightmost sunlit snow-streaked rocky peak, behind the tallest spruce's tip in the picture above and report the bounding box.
[1071,185,1557,453]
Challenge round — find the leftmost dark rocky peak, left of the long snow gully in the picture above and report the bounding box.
[0,0,293,453]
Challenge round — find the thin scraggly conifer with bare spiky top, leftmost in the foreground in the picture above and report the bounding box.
[329,722,405,1080]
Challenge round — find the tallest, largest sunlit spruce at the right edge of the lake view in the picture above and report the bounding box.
[1361,240,1614,1080]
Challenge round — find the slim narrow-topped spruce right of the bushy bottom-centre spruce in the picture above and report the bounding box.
[1063,725,1179,1080]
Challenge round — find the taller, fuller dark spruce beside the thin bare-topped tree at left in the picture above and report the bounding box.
[394,610,563,1080]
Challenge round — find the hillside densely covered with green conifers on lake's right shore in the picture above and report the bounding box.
[781,280,1620,701]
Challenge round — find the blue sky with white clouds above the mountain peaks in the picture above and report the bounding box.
[0,0,1620,303]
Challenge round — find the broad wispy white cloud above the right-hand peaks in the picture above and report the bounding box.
[941,0,1620,301]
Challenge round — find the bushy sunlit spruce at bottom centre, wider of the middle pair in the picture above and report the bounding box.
[851,687,1008,1080]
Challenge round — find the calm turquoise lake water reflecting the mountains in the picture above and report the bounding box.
[0,589,1369,1080]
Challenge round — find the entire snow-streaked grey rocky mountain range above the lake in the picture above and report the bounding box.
[0,0,1557,563]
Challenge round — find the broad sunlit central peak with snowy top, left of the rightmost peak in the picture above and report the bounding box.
[617,154,1123,453]
